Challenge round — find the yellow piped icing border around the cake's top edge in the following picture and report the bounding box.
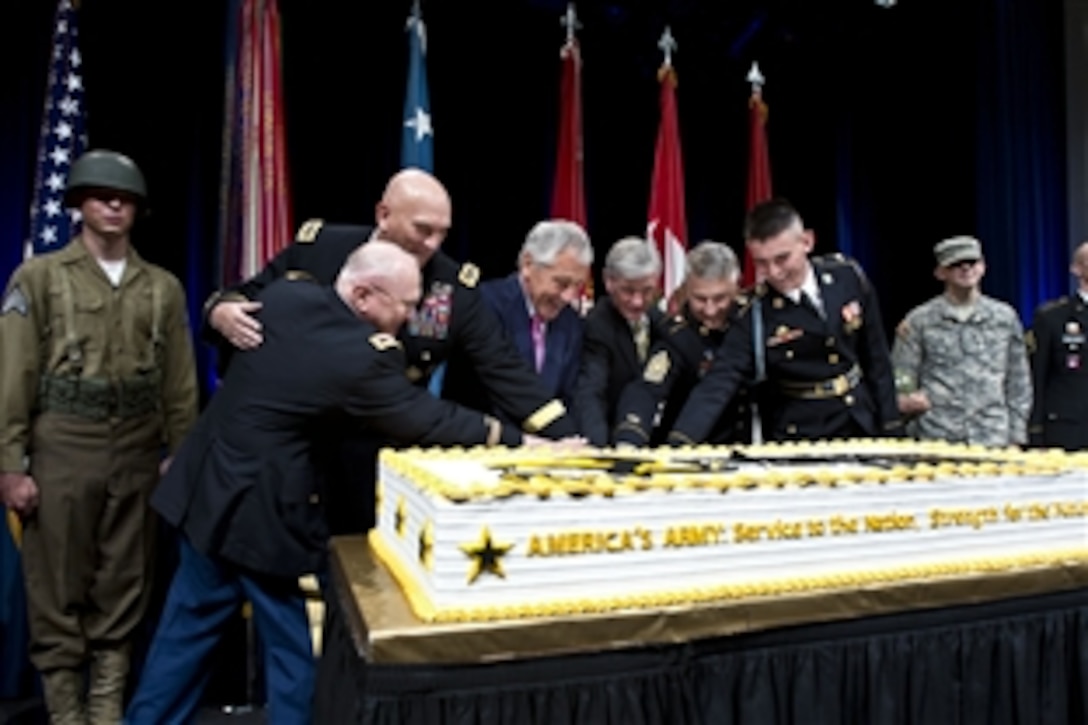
[381,439,1088,502]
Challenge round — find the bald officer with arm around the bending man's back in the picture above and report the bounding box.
[202,169,578,533]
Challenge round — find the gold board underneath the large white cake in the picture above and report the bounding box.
[331,536,1088,664]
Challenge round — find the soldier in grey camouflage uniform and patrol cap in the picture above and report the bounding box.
[892,236,1031,446]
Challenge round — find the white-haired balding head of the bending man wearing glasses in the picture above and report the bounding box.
[336,238,420,333]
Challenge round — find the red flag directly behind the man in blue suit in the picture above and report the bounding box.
[552,36,593,312]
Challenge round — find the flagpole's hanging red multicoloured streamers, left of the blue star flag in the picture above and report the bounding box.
[221,0,294,284]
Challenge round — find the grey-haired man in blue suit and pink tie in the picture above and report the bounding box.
[443,220,593,415]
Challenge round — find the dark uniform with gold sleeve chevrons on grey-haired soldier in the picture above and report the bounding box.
[613,297,752,446]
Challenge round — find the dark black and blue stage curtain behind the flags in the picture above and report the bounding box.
[0,0,1070,374]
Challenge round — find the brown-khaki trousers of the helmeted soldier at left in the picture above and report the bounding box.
[23,411,162,673]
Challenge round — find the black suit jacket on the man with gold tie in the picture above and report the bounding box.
[574,297,668,445]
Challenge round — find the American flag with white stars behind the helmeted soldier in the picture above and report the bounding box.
[26,0,87,256]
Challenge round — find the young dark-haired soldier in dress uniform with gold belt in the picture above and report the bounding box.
[668,199,902,444]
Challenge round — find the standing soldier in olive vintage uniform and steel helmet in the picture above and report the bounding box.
[0,150,197,724]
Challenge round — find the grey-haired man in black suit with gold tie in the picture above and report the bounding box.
[574,237,666,445]
